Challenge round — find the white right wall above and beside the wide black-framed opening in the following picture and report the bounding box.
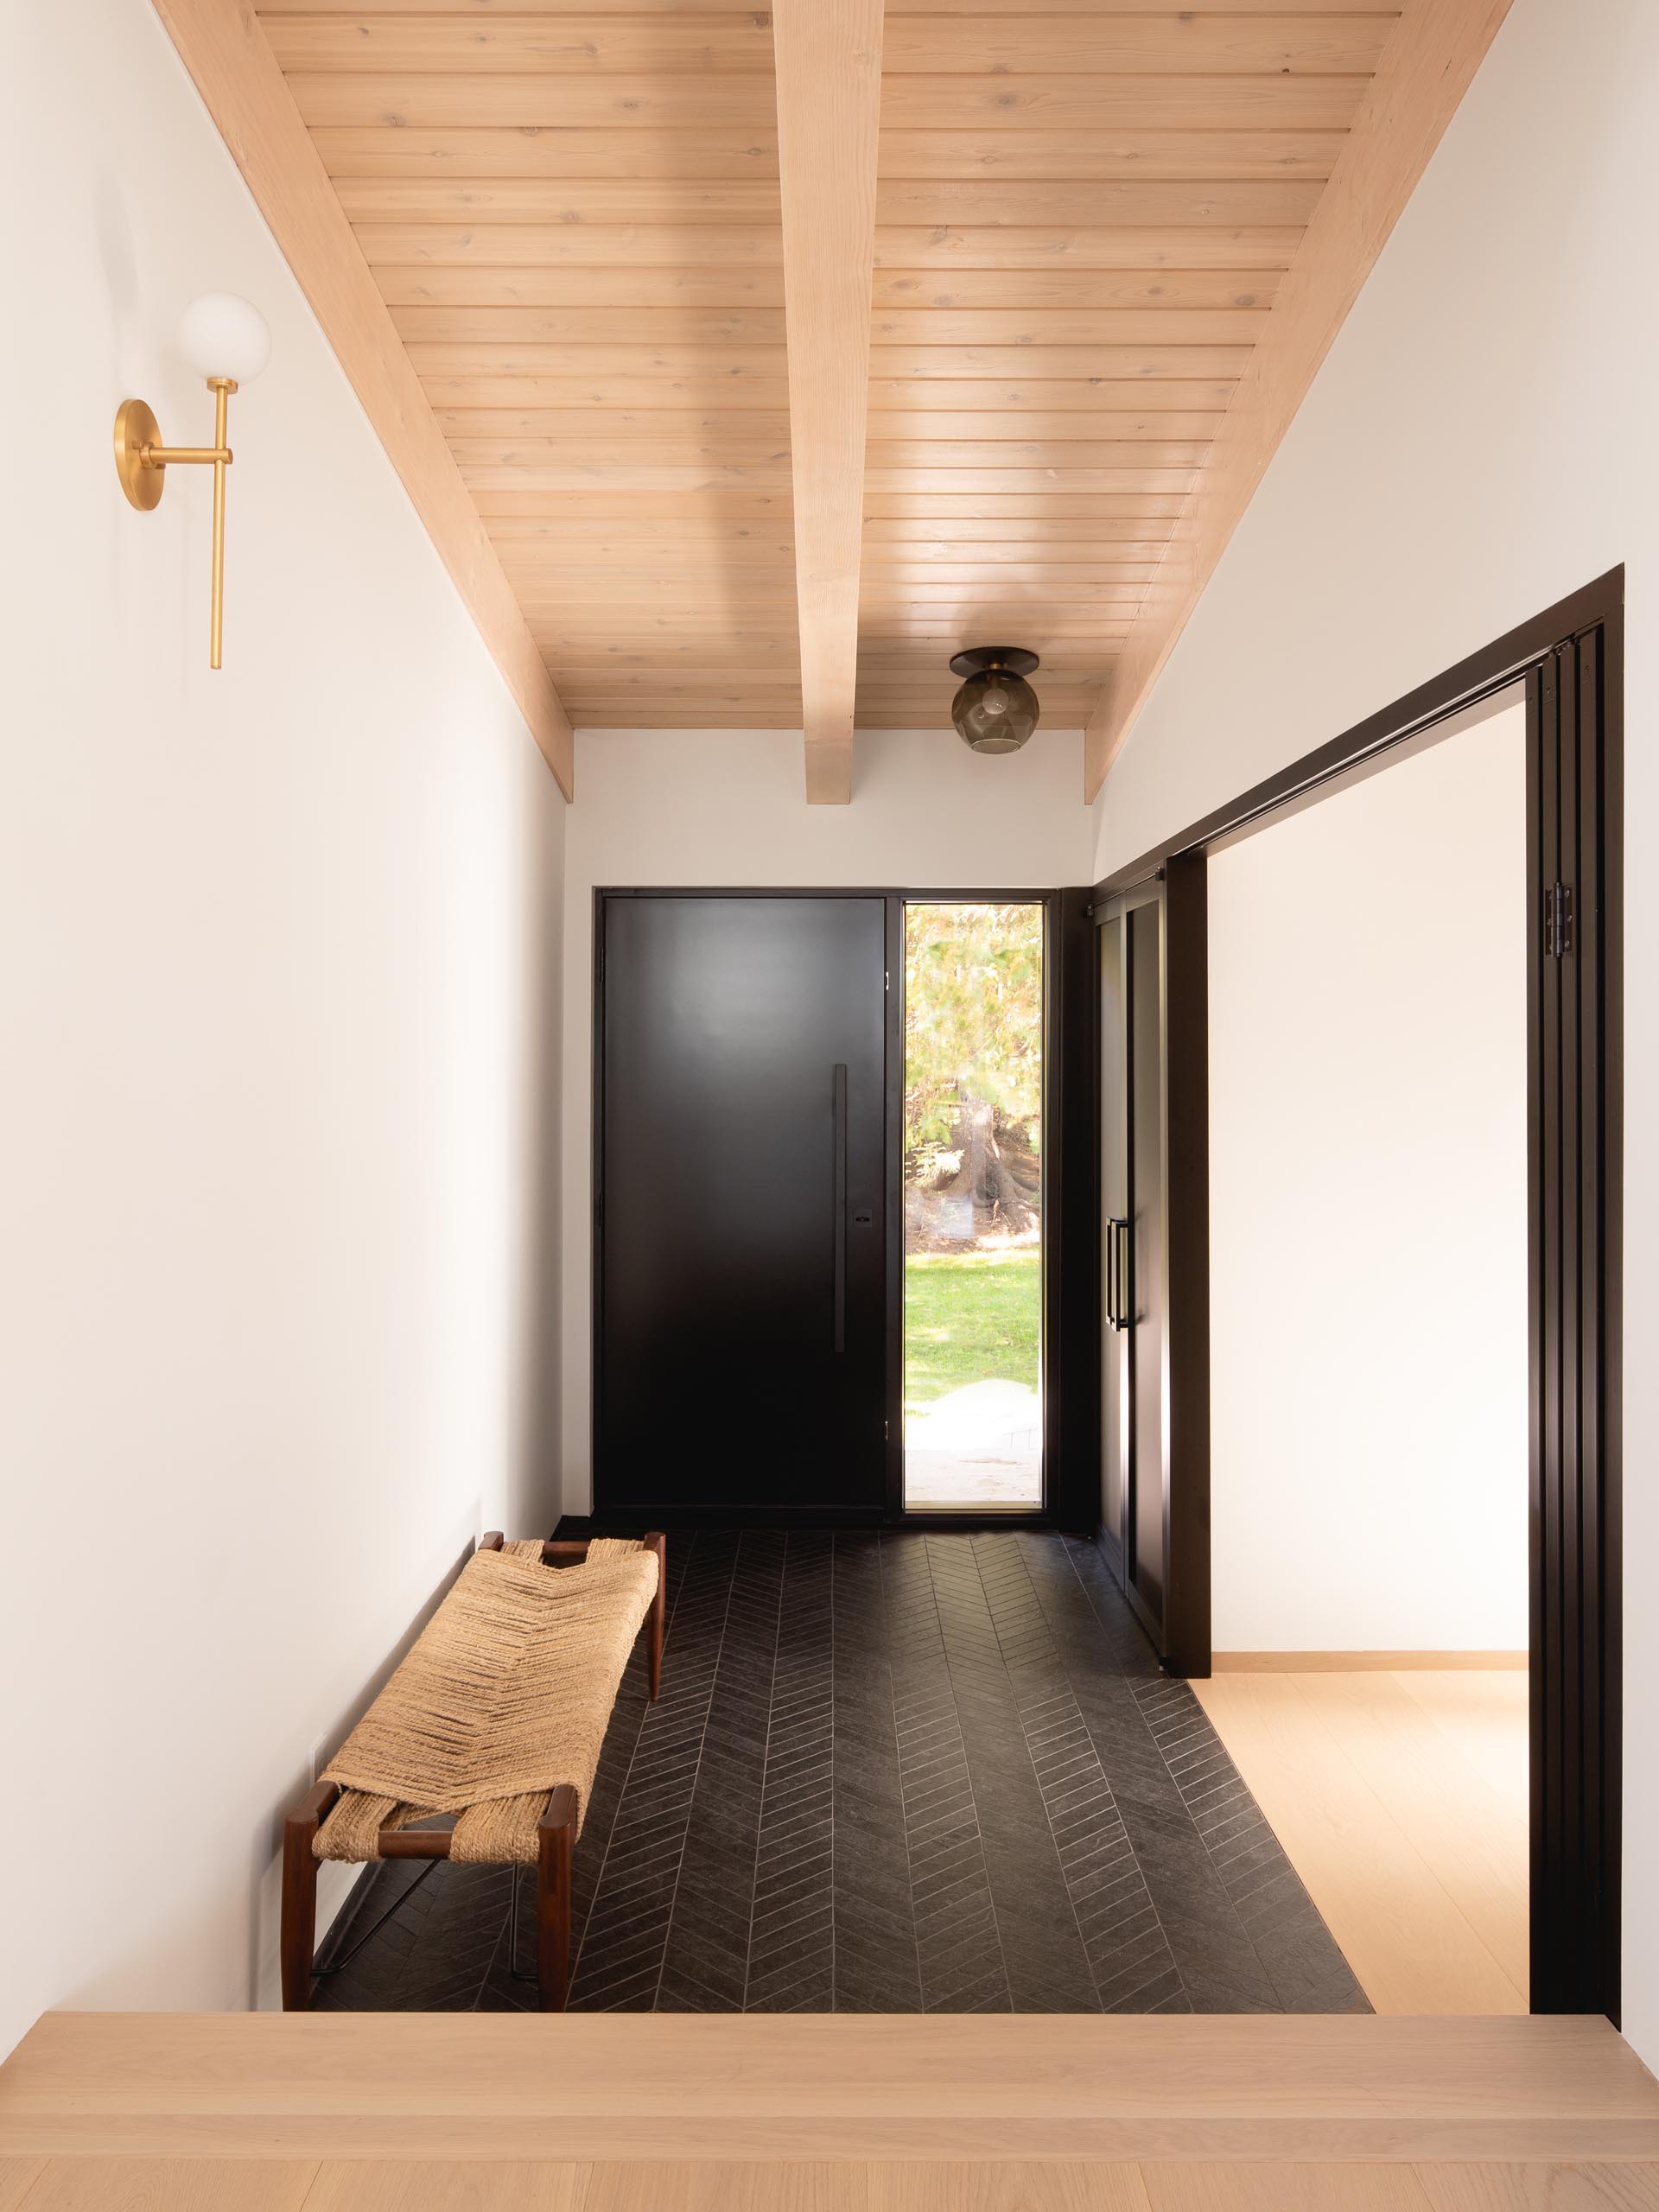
[1097,0,1659,2063]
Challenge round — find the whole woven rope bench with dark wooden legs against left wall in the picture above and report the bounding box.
[283,1535,666,2011]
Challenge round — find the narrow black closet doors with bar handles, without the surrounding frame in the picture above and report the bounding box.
[1099,887,1170,1650]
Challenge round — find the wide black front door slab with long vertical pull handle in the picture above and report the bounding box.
[595,892,887,1517]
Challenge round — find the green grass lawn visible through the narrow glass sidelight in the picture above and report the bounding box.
[905,1245,1042,1411]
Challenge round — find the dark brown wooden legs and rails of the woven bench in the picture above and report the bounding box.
[281,1531,668,2013]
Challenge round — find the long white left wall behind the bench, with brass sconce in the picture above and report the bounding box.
[0,0,564,2050]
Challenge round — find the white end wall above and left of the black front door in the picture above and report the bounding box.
[564,730,1090,1513]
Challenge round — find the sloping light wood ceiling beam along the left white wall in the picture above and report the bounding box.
[155,0,575,798]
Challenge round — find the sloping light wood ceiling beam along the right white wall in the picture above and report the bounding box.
[1084,0,1509,801]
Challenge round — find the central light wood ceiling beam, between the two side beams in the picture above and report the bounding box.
[772,0,882,805]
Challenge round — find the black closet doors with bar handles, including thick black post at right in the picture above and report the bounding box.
[1099,861,1210,1675]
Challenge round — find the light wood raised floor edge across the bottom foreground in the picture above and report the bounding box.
[0,2013,1659,2185]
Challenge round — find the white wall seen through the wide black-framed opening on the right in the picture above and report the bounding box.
[1208,706,1529,1652]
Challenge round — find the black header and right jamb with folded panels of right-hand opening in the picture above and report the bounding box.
[1095,566,1624,2022]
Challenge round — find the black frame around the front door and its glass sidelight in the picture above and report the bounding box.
[588,882,1099,1533]
